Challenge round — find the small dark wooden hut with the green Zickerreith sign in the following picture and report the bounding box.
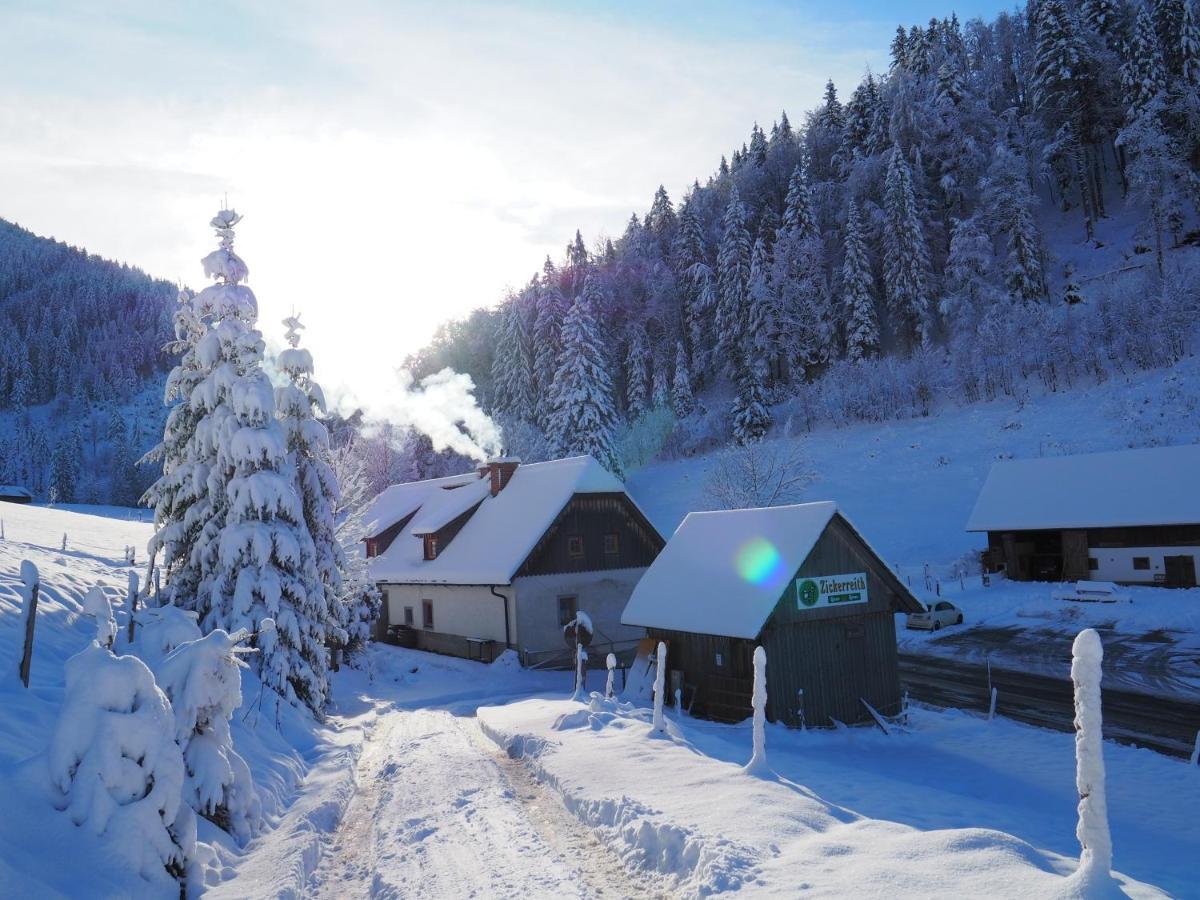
[622,502,924,725]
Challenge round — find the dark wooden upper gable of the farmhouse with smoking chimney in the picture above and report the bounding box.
[515,493,664,577]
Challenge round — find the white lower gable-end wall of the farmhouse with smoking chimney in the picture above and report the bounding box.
[514,568,646,650]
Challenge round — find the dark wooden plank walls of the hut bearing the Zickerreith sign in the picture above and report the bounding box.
[649,515,922,726]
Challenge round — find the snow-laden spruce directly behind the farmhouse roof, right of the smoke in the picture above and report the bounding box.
[551,272,622,475]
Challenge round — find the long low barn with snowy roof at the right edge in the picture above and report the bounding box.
[967,445,1200,587]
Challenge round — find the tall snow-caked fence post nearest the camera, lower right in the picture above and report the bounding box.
[1070,628,1112,887]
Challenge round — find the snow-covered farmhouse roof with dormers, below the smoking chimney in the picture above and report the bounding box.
[368,456,625,584]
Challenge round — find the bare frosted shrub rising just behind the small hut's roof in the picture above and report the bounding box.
[704,439,816,509]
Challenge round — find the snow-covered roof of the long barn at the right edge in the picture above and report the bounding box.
[967,444,1200,532]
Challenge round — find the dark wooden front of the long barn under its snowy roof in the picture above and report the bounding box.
[984,524,1200,587]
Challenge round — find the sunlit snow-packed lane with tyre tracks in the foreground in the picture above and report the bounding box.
[304,709,655,898]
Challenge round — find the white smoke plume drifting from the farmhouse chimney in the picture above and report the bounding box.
[370,368,500,462]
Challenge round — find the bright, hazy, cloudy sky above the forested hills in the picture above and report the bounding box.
[0,0,1002,415]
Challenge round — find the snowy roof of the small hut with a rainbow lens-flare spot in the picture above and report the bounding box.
[620,500,838,638]
